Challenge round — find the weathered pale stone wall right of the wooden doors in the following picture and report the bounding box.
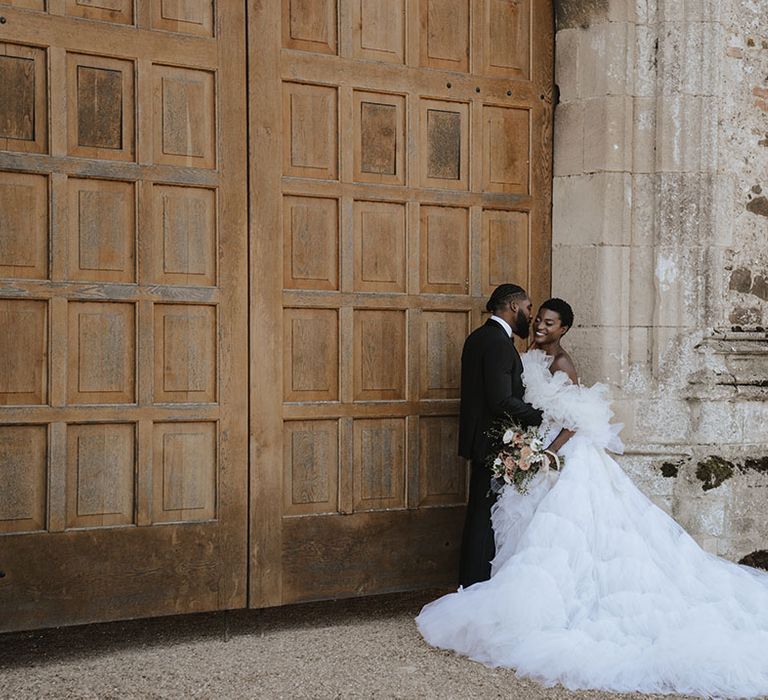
[552,0,768,559]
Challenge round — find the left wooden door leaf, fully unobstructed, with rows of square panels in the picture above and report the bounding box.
[0,0,247,631]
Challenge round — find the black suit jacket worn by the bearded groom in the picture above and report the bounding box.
[459,319,541,461]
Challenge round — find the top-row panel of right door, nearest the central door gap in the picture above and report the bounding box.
[282,0,338,54]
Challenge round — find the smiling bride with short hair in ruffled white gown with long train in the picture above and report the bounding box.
[416,299,768,697]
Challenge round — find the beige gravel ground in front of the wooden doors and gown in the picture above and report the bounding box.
[0,591,696,700]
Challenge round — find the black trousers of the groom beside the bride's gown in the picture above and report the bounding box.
[459,461,496,588]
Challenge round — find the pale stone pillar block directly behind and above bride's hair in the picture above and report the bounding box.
[552,245,629,326]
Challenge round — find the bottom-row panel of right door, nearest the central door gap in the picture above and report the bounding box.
[283,420,339,515]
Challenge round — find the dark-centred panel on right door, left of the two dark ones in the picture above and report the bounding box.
[354,90,405,185]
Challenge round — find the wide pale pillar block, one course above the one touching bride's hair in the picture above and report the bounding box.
[552,173,632,245]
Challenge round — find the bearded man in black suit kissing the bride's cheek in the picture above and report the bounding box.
[459,284,541,588]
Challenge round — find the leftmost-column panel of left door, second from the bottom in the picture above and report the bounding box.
[0,299,48,406]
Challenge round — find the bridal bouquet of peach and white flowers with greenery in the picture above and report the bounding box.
[488,417,563,493]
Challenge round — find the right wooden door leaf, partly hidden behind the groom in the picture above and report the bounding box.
[248,0,553,606]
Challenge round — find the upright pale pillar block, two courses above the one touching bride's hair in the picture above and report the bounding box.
[584,96,633,172]
